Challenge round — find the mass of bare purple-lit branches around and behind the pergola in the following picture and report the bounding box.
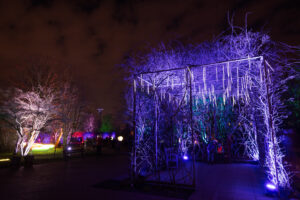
[125,23,295,188]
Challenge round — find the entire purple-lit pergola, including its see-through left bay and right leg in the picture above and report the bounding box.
[131,56,289,187]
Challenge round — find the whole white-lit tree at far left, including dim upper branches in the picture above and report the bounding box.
[0,64,62,156]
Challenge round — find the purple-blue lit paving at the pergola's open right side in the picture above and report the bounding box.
[189,163,272,200]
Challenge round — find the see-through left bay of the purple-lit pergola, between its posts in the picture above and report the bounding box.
[134,68,192,185]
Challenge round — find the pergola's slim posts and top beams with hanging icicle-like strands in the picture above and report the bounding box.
[131,56,288,190]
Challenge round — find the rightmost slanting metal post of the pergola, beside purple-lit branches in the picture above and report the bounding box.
[263,60,280,195]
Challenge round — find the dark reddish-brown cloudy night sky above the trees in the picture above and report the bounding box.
[0,0,300,113]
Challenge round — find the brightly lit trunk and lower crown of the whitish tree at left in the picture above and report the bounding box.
[2,86,57,156]
